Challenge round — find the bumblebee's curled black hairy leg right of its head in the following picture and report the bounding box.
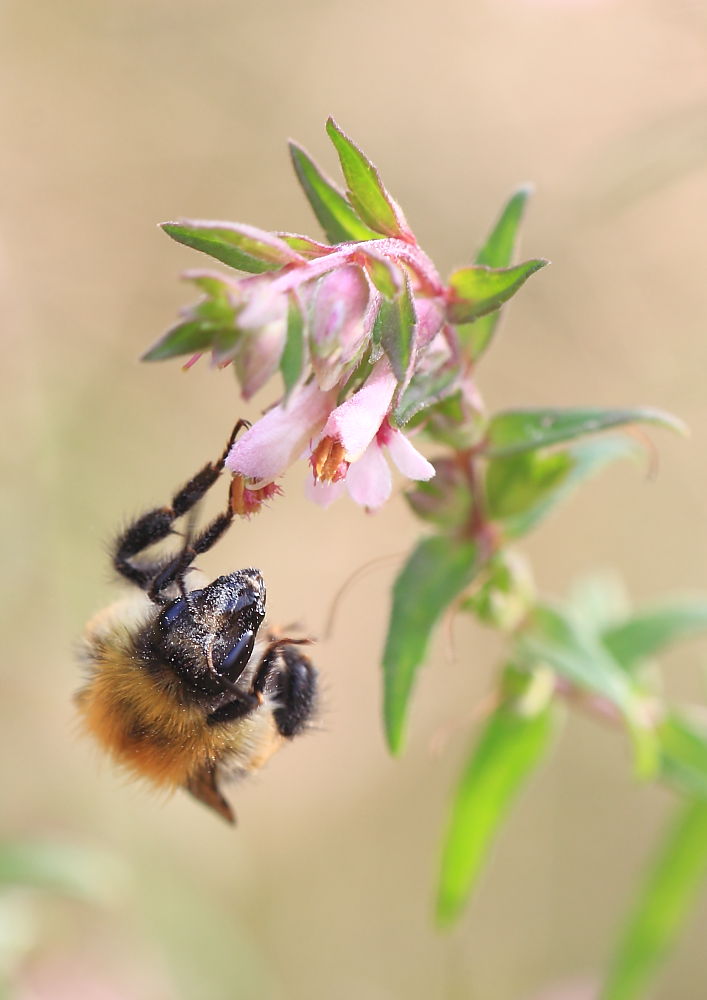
[253,640,317,738]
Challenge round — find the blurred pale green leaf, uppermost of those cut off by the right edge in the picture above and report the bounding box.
[603,599,707,670]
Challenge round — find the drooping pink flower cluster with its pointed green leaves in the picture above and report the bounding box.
[145,120,544,513]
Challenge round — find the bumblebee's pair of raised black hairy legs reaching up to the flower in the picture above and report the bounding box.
[113,420,249,599]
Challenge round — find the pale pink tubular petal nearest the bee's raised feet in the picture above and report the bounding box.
[226,382,336,479]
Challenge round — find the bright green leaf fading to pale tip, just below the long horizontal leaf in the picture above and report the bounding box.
[486,435,637,538]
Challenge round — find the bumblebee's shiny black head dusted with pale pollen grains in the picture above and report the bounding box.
[155,569,265,692]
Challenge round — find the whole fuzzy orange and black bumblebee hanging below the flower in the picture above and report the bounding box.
[76,421,317,823]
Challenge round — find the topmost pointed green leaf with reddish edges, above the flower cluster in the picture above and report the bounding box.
[326,118,407,237]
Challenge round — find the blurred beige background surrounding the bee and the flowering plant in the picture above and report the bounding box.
[0,0,707,1000]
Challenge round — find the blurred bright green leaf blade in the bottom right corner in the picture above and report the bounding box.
[601,801,707,1000]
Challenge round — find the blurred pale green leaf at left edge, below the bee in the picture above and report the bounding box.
[0,840,126,903]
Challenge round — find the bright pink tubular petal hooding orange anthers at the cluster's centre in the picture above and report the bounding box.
[324,358,397,462]
